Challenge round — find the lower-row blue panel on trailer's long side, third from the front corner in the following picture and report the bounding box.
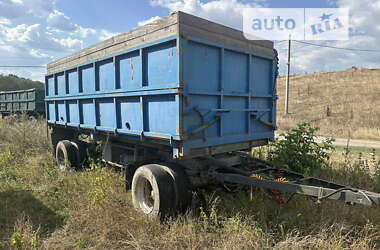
[96,98,116,128]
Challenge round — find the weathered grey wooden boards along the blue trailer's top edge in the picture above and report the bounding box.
[47,11,274,75]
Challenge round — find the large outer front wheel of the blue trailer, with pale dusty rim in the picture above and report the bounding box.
[132,164,175,219]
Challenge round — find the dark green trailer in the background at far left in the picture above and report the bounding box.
[0,89,45,116]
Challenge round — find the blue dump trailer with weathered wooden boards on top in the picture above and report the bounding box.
[45,12,378,216]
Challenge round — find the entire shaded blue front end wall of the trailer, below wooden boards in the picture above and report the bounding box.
[181,38,275,155]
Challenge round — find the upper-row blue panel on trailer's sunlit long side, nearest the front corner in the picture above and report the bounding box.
[143,40,178,86]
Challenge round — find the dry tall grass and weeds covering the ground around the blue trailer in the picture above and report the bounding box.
[0,119,380,249]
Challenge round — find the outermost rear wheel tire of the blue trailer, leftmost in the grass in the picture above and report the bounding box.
[55,140,78,170]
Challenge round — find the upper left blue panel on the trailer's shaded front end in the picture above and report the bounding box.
[184,41,220,91]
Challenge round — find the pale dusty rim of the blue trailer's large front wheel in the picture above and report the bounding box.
[137,178,154,214]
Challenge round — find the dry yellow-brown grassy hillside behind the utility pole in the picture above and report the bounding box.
[277,67,380,140]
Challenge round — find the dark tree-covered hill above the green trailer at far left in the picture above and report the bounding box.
[0,74,44,91]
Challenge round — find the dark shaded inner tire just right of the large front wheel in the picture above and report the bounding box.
[163,162,191,213]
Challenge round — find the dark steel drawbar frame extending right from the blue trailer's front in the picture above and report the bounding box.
[209,158,380,207]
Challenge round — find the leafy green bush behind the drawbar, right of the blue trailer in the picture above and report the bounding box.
[268,123,334,175]
